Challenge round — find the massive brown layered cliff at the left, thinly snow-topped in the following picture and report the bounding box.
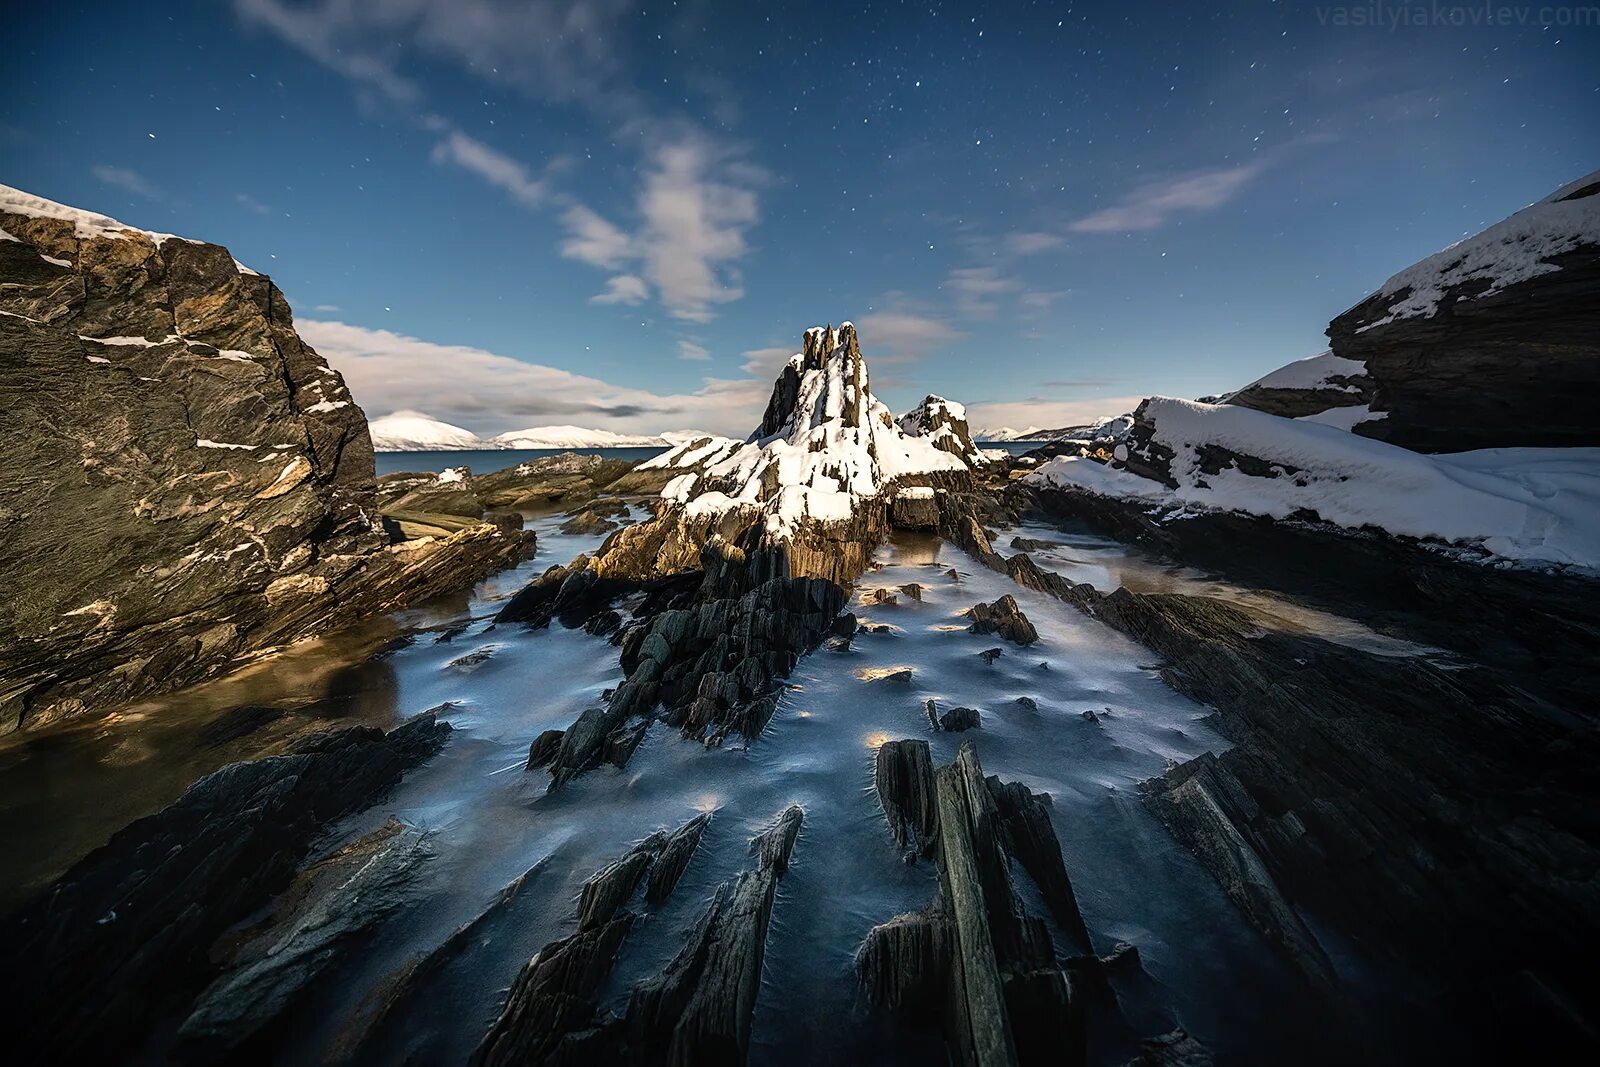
[0,187,520,731]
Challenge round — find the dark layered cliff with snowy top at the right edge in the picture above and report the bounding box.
[1229,171,1600,453]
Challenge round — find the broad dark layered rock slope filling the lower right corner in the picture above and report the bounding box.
[947,534,1600,1059]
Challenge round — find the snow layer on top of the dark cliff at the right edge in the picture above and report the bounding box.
[1358,171,1600,333]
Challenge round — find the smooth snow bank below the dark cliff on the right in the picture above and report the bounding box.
[1027,397,1600,568]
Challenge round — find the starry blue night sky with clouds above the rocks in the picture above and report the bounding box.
[0,0,1600,435]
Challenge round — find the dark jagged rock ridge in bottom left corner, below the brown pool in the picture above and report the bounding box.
[0,712,450,1062]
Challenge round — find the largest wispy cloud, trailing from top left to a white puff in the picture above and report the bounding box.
[234,0,766,323]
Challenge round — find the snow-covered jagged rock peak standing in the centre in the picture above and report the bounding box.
[643,316,981,536]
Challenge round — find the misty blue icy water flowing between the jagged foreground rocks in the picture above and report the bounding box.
[0,517,1382,1064]
